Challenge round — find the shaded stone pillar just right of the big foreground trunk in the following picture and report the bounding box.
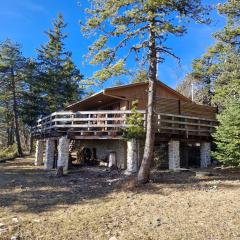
[168,140,180,170]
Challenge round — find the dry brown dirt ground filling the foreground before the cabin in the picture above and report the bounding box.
[0,158,240,240]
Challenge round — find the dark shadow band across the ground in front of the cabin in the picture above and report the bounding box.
[0,158,240,213]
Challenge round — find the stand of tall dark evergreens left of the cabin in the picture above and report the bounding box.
[0,14,83,158]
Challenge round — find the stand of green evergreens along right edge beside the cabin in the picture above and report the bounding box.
[178,0,240,165]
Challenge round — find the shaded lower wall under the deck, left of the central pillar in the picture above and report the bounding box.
[74,139,127,169]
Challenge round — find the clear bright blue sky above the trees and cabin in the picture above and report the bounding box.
[0,0,224,91]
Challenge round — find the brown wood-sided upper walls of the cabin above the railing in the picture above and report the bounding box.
[67,82,217,119]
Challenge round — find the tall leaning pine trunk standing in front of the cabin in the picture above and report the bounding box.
[138,16,157,183]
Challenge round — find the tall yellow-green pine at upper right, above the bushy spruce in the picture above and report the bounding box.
[178,0,240,109]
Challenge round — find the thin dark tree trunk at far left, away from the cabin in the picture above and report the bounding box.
[11,69,23,157]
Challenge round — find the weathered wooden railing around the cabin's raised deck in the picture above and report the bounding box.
[33,110,217,136]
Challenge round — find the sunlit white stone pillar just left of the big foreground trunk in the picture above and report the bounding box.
[126,139,139,174]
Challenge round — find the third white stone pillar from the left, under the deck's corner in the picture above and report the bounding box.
[57,136,69,173]
